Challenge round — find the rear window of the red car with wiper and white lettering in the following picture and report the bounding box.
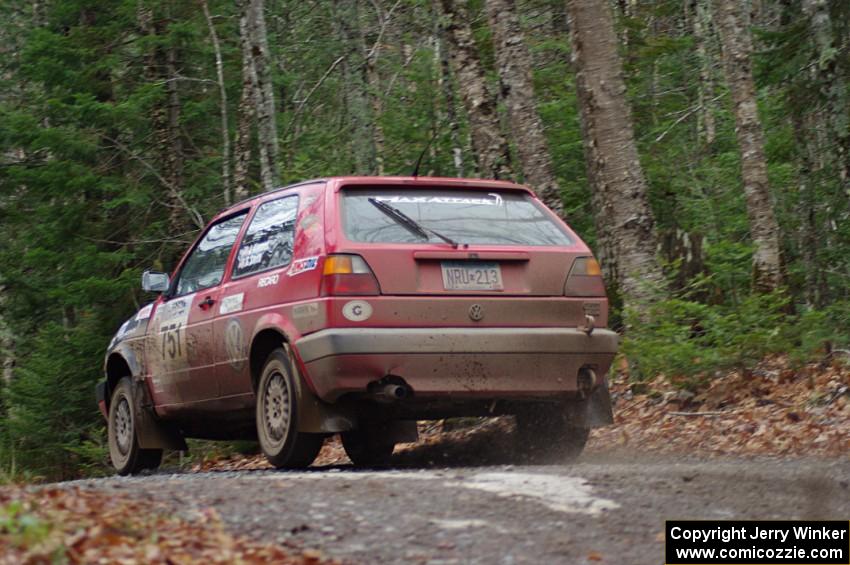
[342,188,573,246]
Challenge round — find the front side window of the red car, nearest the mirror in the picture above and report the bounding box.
[175,214,246,296]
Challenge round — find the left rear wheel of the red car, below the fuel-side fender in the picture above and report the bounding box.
[256,348,325,469]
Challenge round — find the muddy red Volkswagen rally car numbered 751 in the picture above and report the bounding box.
[97,177,618,474]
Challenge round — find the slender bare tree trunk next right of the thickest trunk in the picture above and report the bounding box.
[714,0,785,291]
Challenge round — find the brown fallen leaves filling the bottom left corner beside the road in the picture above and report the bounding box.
[0,487,331,565]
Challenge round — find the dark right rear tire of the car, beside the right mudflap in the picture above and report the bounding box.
[516,405,590,463]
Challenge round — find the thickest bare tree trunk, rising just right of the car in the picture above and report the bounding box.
[567,0,664,315]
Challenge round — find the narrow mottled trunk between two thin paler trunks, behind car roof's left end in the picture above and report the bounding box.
[233,3,256,201]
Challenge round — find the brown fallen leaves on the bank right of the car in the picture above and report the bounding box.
[590,357,850,457]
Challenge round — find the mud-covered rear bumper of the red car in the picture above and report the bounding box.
[295,328,618,402]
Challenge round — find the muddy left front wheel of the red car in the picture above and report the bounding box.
[107,377,162,475]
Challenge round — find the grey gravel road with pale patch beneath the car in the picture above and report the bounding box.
[65,453,850,564]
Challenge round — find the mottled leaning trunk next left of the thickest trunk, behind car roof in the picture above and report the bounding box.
[440,0,513,179]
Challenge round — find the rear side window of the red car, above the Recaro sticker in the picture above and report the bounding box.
[233,196,298,278]
